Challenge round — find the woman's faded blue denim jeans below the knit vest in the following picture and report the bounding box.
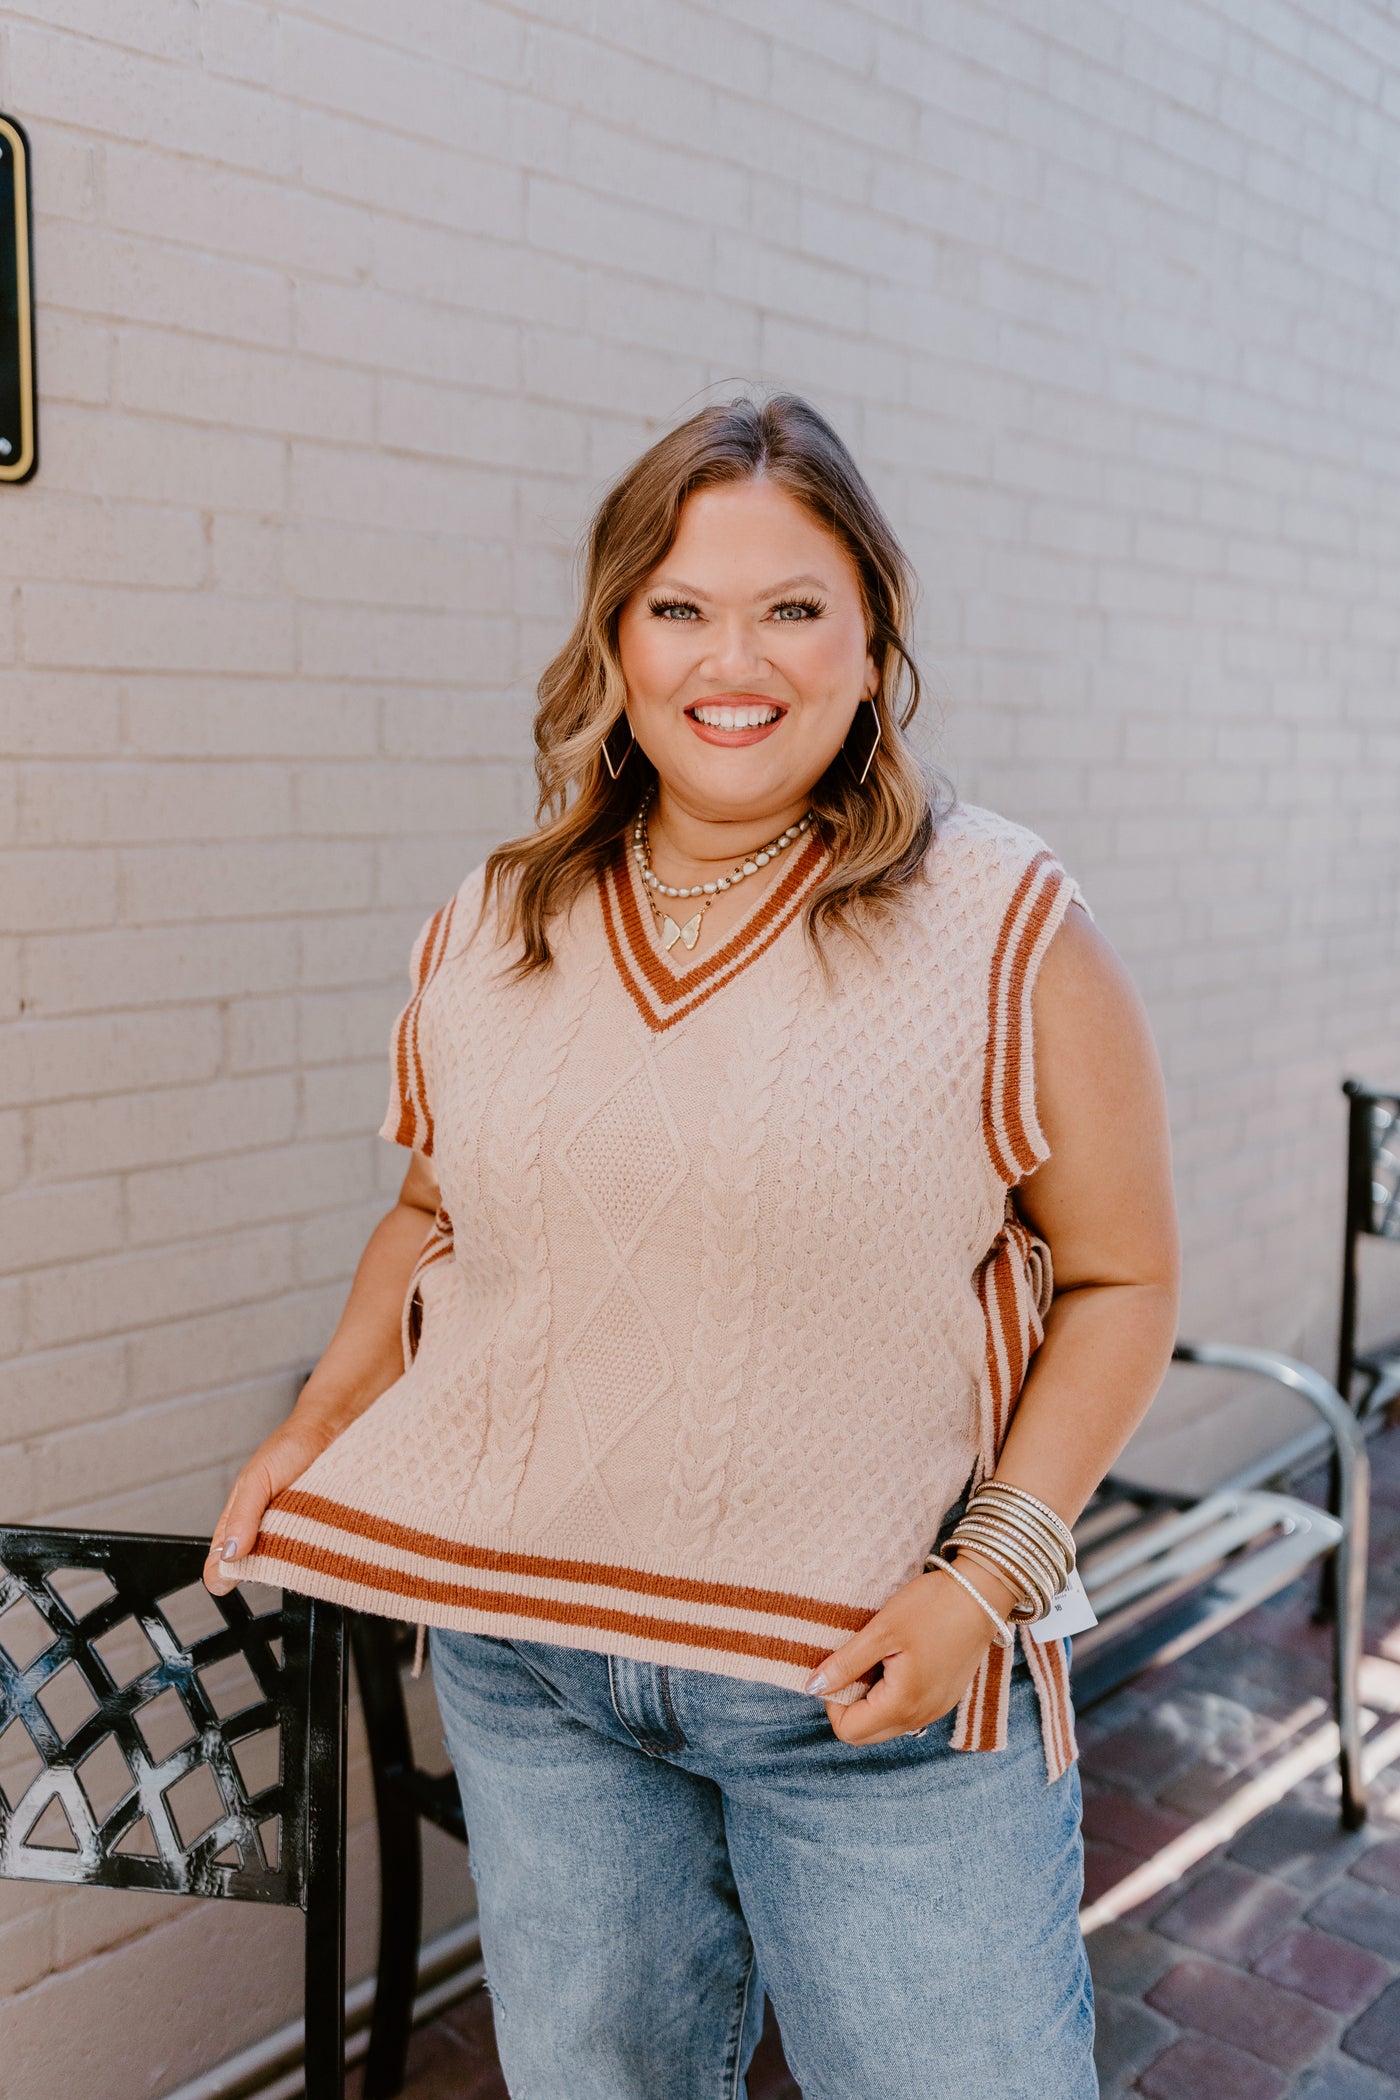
[432,1630,1098,2100]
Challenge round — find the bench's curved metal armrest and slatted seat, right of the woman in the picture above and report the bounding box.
[1070,1342,1371,1829]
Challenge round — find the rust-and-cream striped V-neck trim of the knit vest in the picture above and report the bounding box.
[598,832,827,1035]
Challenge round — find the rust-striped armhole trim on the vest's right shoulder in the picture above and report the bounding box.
[982,846,1089,1189]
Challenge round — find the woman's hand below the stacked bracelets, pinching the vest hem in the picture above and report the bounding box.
[806,1567,1012,1743]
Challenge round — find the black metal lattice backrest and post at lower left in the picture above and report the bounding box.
[0,1525,346,2100]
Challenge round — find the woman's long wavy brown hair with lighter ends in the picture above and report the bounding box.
[483,395,940,974]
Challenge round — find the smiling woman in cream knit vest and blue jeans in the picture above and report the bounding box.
[206,397,1175,2100]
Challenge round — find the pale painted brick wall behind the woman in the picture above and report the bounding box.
[0,0,1400,2100]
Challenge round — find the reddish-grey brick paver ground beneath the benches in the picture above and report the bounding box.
[367,1430,1400,2100]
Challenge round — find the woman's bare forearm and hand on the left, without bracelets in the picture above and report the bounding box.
[204,1153,439,1596]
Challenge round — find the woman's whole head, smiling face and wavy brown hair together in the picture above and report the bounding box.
[476,395,936,970]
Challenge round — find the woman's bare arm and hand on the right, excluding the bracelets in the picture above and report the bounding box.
[810,911,1178,1743]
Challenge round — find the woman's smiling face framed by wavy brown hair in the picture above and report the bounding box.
[617,481,875,821]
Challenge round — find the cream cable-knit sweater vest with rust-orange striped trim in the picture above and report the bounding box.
[235,806,1077,1779]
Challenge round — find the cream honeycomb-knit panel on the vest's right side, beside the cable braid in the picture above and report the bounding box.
[722,895,1001,1583]
